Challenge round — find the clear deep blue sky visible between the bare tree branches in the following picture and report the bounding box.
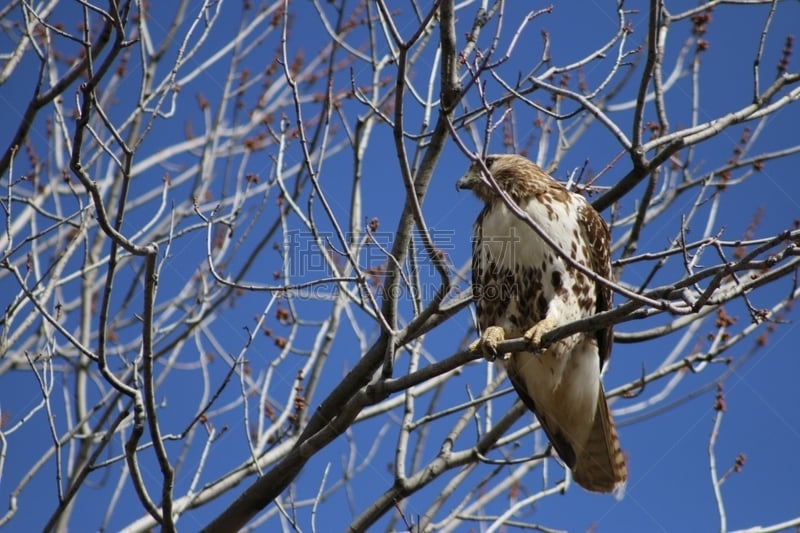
[0,0,800,531]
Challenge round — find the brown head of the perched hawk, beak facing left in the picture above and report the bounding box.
[456,154,552,203]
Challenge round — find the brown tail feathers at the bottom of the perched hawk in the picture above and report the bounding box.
[572,386,628,492]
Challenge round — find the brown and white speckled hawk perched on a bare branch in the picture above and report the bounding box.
[457,155,628,492]
